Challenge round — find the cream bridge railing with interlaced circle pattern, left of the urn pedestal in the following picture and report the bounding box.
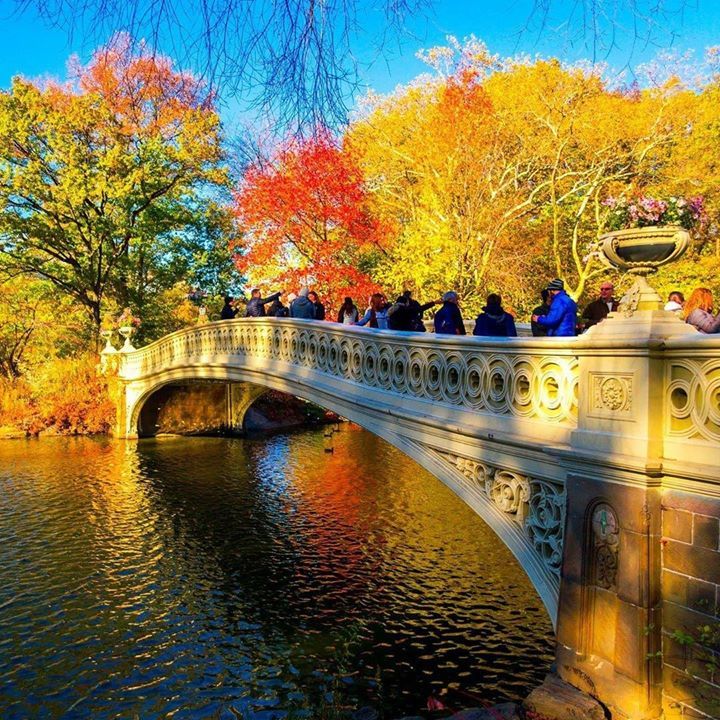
[120,319,578,426]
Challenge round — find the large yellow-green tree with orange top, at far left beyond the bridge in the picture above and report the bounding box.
[0,38,226,326]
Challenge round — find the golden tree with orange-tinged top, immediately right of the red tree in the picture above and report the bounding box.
[348,44,542,310]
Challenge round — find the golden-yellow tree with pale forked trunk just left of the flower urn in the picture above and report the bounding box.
[485,60,683,297]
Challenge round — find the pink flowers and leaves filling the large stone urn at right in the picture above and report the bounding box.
[603,195,707,231]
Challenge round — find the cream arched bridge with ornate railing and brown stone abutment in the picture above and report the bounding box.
[111,309,720,720]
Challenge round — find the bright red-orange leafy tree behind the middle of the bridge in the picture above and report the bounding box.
[233,132,387,306]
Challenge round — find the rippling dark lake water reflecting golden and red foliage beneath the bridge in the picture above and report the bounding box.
[0,425,552,720]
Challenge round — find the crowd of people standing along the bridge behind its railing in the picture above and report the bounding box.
[220,278,720,337]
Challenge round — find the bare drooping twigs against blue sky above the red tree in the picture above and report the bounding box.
[14,0,432,131]
